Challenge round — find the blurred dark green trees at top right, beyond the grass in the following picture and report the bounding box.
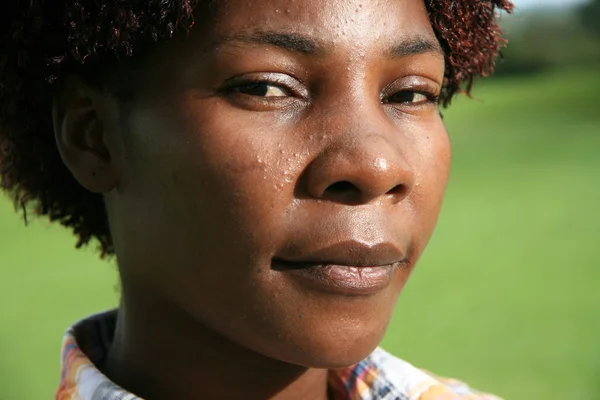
[497,0,600,75]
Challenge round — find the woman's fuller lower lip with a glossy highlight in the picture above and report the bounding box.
[275,261,404,296]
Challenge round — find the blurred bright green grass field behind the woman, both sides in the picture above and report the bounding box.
[0,70,600,400]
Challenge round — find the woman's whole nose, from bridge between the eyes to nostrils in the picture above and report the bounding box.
[306,101,414,204]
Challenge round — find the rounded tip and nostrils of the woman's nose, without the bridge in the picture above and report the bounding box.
[305,132,415,205]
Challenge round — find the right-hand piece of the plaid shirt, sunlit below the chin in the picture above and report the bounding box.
[332,349,501,400]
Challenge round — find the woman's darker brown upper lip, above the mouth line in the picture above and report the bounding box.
[274,240,406,267]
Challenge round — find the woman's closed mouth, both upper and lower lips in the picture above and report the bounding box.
[272,241,408,296]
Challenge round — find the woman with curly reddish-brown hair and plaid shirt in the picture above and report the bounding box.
[0,0,512,400]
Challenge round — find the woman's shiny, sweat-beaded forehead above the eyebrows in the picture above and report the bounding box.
[201,0,435,54]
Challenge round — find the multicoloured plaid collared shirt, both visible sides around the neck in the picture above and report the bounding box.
[55,311,500,400]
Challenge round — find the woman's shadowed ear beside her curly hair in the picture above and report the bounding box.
[53,76,117,193]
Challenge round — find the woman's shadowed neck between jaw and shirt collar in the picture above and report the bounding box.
[101,293,328,400]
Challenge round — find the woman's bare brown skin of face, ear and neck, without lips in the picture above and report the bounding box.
[54,0,450,399]
